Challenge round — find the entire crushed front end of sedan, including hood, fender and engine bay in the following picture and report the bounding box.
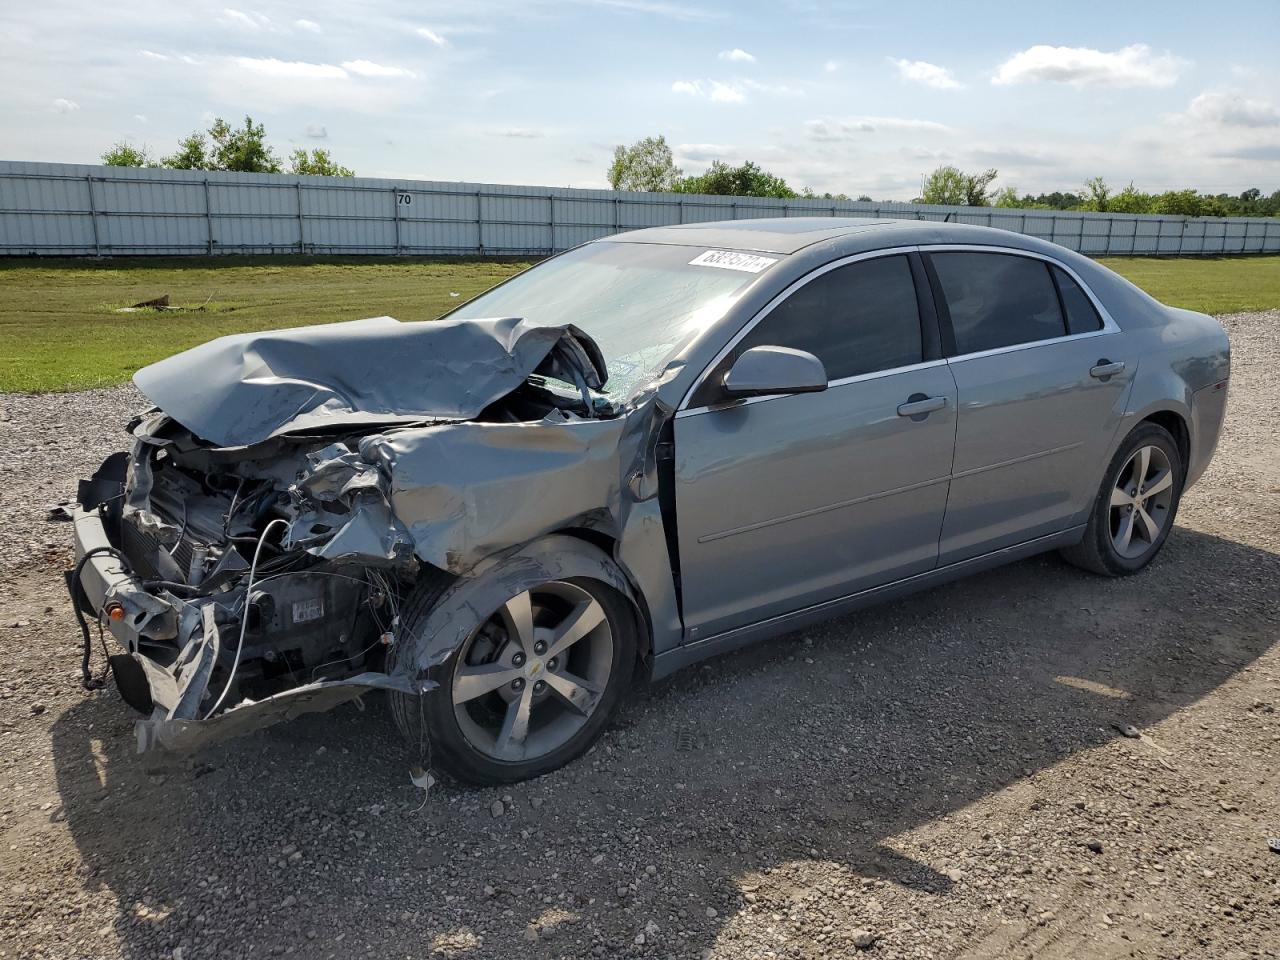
[69,317,670,749]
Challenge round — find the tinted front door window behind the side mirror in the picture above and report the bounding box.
[735,256,923,380]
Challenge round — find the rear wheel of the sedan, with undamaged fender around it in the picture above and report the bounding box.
[1060,421,1187,577]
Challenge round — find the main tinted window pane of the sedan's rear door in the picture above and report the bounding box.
[931,252,1066,353]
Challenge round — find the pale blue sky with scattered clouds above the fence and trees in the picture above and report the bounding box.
[0,0,1280,200]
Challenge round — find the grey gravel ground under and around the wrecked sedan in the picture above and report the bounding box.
[0,312,1280,960]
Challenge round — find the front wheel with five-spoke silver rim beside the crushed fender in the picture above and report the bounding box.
[392,554,637,786]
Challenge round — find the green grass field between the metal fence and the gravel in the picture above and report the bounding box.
[0,257,1280,392]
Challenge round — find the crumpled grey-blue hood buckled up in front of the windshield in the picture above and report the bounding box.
[133,316,608,447]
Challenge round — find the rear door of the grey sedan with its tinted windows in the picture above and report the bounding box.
[927,250,1137,566]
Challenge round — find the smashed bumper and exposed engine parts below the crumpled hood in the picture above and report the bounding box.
[72,412,425,749]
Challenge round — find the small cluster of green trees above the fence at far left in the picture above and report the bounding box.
[102,116,356,177]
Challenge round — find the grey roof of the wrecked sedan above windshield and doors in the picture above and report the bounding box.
[596,216,1061,255]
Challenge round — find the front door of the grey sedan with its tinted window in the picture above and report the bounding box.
[675,253,956,640]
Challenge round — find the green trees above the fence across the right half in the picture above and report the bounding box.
[608,137,1280,216]
